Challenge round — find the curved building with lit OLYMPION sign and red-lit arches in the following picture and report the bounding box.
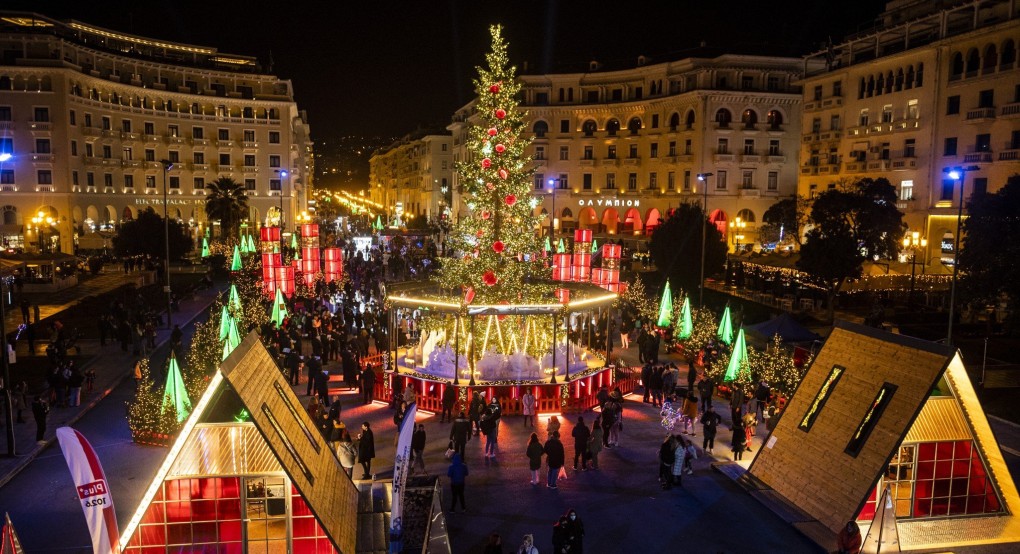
[448,55,804,248]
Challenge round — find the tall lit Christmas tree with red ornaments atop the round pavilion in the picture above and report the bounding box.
[439,26,552,304]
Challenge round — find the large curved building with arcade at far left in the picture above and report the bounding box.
[0,12,313,252]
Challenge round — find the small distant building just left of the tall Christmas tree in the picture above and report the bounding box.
[368,133,454,223]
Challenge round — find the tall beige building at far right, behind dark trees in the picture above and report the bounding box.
[799,0,1020,265]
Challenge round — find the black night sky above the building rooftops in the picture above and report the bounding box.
[2,0,884,142]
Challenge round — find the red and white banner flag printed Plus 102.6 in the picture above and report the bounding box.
[57,427,119,554]
